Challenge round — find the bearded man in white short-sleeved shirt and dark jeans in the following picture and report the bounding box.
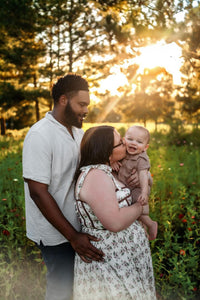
[23,74,103,300]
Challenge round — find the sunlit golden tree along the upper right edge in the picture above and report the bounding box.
[170,0,200,126]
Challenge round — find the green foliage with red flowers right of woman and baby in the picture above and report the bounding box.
[148,133,200,299]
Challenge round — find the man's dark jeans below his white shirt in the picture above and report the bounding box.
[37,242,75,300]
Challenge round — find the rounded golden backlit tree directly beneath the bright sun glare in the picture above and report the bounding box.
[120,67,174,130]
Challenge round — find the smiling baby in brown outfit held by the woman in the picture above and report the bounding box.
[113,126,158,240]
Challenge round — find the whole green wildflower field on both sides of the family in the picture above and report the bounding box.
[0,124,200,300]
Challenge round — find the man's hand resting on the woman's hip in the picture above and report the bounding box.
[70,232,104,263]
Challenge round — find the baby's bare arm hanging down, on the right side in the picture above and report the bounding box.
[137,169,149,205]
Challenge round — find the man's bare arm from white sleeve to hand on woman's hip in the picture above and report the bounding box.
[25,179,104,262]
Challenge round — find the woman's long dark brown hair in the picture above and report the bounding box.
[75,126,114,181]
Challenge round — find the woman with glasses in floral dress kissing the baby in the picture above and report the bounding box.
[74,126,156,300]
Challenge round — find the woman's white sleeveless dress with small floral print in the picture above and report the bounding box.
[73,165,156,300]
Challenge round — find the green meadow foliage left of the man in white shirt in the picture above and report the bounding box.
[0,130,45,300]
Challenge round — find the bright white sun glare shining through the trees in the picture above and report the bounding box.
[97,41,183,96]
